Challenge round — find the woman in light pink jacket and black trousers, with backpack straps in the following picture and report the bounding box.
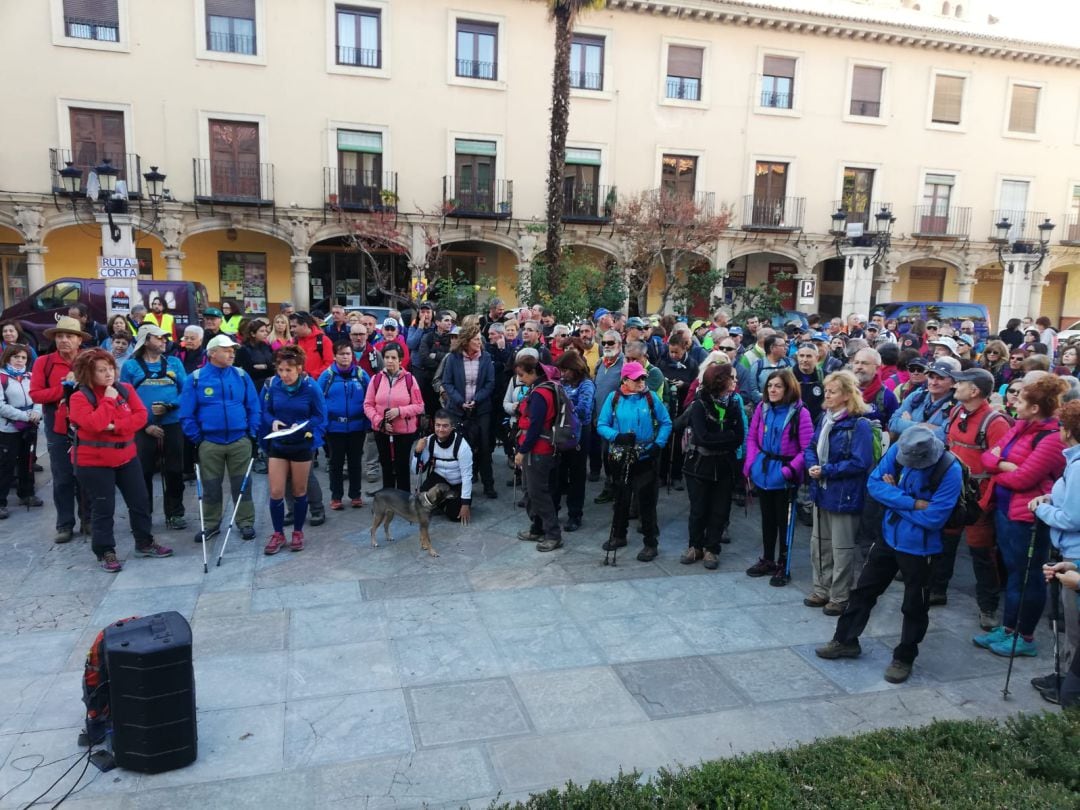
[364,343,423,492]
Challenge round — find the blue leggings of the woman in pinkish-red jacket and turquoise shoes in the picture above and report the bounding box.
[994,509,1050,636]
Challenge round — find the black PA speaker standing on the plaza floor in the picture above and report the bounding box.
[105,610,198,773]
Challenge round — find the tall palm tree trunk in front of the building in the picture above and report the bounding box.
[544,0,606,287]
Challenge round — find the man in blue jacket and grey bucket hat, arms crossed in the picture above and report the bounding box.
[814,424,963,684]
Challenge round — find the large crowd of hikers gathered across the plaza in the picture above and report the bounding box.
[0,299,1080,704]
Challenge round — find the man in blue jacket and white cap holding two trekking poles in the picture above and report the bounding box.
[180,335,259,543]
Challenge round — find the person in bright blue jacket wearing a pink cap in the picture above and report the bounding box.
[596,363,672,563]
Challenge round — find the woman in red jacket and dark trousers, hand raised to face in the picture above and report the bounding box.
[68,349,173,573]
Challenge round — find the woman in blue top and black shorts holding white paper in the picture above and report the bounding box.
[261,346,326,554]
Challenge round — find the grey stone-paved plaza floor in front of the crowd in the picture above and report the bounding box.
[0,460,1051,810]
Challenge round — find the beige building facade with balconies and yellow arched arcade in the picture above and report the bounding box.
[0,0,1080,326]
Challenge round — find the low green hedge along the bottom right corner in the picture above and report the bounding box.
[491,711,1080,810]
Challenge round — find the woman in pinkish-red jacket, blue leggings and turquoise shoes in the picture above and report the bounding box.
[972,376,1068,656]
